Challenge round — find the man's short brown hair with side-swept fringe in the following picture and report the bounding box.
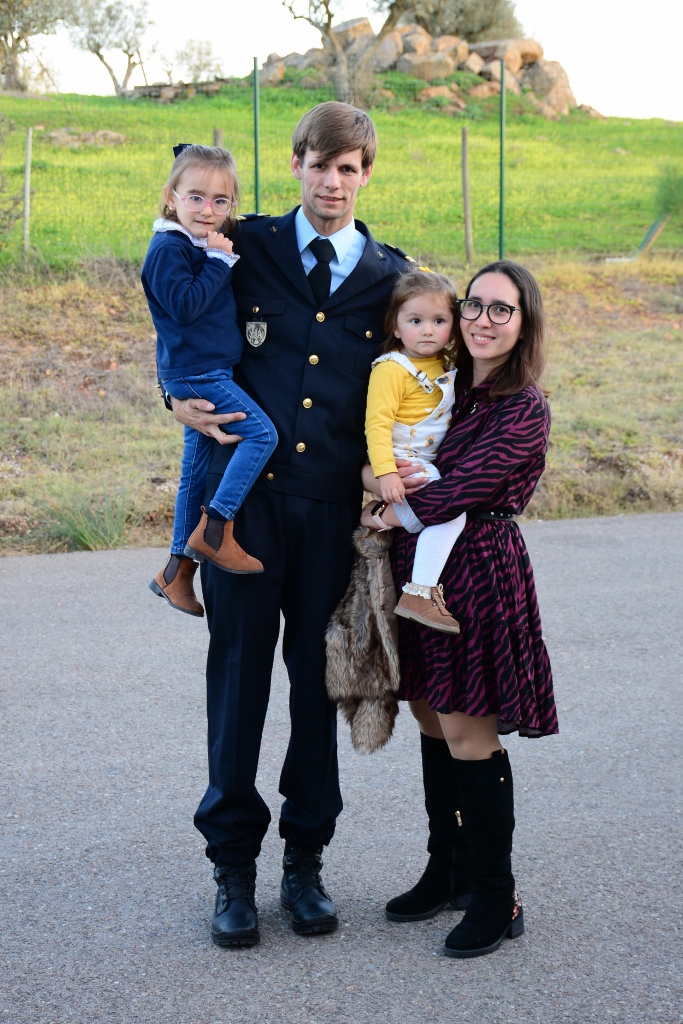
[292,100,377,171]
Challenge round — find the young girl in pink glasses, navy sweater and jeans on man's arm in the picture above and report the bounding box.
[142,145,278,616]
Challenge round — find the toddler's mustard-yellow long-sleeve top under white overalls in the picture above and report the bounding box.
[366,355,443,476]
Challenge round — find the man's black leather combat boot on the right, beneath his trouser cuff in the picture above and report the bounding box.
[280,842,339,935]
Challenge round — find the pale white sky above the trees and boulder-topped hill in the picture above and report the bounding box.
[25,0,683,121]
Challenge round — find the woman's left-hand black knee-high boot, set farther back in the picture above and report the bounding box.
[386,733,470,921]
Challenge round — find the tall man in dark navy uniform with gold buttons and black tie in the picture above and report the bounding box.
[172,102,422,945]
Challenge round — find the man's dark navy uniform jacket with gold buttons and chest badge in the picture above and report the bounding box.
[209,208,409,504]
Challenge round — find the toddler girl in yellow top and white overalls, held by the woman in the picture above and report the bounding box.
[366,269,465,633]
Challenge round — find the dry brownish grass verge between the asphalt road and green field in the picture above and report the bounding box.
[0,258,683,554]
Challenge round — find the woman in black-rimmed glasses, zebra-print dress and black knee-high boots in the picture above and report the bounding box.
[361,260,558,957]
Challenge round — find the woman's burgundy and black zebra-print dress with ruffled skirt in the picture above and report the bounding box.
[392,382,558,736]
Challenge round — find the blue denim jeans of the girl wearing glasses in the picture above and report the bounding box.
[162,368,278,555]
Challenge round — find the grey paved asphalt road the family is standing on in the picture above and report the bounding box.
[0,514,683,1024]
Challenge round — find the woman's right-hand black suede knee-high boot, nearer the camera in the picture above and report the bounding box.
[444,751,524,957]
